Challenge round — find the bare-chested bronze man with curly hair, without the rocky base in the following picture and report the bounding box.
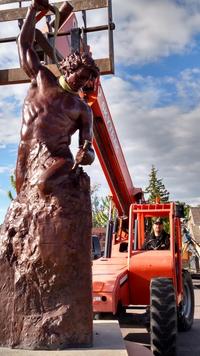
[16,0,99,194]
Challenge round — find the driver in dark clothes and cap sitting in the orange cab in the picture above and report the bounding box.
[142,218,170,250]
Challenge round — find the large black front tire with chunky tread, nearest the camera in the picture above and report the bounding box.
[150,278,177,356]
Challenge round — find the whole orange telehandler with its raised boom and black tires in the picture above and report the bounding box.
[87,76,194,356]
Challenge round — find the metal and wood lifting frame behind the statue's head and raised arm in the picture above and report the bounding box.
[0,0,115,85]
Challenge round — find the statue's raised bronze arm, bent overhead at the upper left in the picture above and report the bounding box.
[18,0,48,79]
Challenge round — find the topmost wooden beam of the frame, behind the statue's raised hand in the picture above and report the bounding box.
[0,0,108,22]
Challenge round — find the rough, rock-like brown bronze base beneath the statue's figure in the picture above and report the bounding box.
[0,169,92,350]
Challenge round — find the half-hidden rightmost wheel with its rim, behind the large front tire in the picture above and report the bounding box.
[178,270,194,331]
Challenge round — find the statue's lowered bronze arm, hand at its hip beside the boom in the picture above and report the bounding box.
[76,105,95,165]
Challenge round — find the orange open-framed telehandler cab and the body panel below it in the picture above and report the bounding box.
[128,203,182,305]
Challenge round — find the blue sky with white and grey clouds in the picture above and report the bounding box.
[0,0,200,223]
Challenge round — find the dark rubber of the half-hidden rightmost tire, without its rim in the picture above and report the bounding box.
[177,270,194,331]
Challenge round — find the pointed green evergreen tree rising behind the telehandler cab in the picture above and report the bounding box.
[145,165,169,203]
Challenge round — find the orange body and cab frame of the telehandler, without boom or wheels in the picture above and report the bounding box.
[93,203,183,314]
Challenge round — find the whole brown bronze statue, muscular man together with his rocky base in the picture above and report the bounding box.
[0,0,99,349]
